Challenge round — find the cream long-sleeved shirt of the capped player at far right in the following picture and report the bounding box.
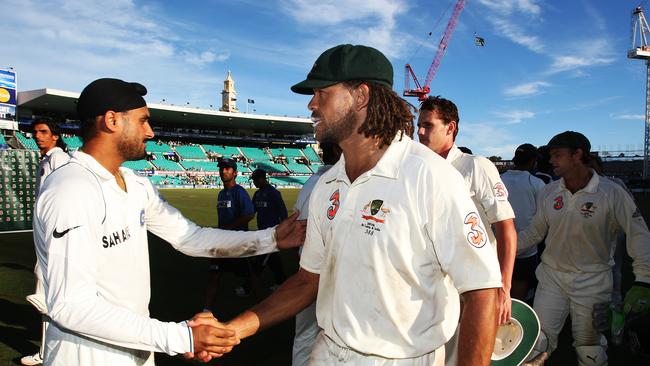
[518,170,650,282]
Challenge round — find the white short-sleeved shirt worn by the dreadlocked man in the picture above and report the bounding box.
[300,137,501,358]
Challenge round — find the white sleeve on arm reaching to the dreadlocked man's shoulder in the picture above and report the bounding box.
[143,178,276,258]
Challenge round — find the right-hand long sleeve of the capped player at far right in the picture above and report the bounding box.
[612,185,650,283]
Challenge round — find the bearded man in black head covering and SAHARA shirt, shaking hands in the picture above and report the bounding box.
[34,79,304,366]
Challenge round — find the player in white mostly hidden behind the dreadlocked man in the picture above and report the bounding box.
[291,142,341,366]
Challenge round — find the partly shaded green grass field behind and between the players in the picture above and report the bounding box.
[0,189,650,366]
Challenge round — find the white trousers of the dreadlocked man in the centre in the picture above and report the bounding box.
[309,331,445,366]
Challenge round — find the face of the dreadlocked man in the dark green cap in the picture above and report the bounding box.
[307,83,357,144]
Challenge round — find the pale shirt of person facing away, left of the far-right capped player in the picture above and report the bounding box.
[501,169,545,258]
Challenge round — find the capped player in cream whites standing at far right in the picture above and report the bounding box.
[518,131,650,366]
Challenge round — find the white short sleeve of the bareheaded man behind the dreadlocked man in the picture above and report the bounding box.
[472,157,515,225]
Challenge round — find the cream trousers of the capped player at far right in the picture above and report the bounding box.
[533,263,612,366]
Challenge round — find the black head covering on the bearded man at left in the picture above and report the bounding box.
[77,78,147,119]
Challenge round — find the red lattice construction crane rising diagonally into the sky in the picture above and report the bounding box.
[404,0,465,101]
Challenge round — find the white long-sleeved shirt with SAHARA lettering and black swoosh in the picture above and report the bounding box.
[34,151,276,365]
